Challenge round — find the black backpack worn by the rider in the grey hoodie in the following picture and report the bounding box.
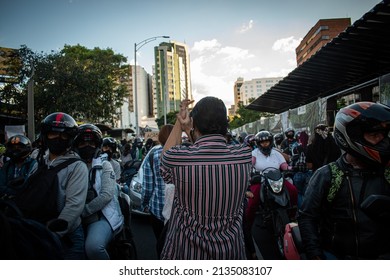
[14,158,81,223]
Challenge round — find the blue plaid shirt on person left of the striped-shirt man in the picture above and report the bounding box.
[141,146,165,221]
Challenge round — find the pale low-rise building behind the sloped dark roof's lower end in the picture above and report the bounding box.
[239,77,283,106]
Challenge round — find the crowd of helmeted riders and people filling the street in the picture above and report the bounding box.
[0,97,390,260]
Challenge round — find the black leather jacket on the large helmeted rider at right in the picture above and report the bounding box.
[298,157,390,259]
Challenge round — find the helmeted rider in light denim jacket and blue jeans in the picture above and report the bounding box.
[73,124,123,260]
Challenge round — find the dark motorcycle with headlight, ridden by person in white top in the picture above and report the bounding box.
[252,167,296,258]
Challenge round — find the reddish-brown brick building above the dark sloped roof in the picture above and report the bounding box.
[295,18,351,66]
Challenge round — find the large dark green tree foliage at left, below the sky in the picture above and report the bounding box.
[2,45,129,128]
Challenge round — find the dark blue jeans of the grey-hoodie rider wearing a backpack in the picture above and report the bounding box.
[61,225,85,260]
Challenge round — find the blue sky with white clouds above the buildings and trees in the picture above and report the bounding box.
[0,0,380,108]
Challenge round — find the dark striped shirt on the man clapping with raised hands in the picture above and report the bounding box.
[160,135,251,260]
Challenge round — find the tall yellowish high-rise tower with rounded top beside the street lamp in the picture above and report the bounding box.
[154,41,193,118]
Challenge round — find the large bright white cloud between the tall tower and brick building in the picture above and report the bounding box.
[190,37,298,108]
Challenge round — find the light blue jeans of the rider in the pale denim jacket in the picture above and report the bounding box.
[85,216,114,260]
